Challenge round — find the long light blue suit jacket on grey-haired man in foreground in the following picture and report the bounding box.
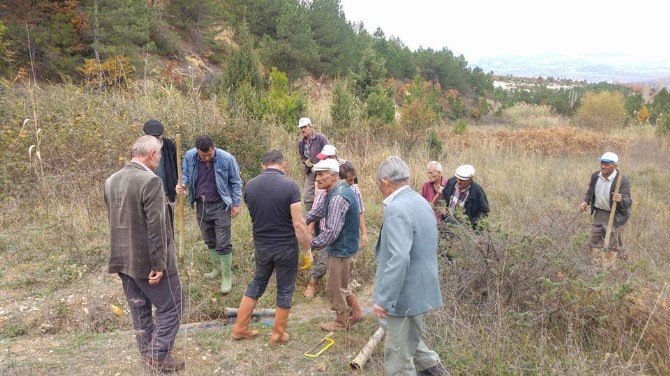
[374,187,443,316]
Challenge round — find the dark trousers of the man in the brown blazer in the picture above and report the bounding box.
[119,273,182,359]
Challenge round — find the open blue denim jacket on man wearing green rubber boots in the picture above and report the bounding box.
[182,148,242,210]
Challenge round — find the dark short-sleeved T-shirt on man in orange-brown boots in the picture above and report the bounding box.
[244,168,300,244]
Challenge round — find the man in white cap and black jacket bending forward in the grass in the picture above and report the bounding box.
[442,165,489,228]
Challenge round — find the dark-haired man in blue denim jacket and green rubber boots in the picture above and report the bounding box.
[177,136,242,294]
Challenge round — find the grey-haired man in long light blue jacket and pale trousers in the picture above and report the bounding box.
[374,156,448,375]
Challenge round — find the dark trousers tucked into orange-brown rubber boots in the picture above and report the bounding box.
[244,244,298,309]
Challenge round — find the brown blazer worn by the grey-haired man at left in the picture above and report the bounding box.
[105,162,177,279]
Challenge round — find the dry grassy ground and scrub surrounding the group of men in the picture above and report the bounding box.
[0,82,670,375]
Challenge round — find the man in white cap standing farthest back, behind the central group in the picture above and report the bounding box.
[298,117,330,210]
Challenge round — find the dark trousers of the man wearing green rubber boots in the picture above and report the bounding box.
[195,201,233,255]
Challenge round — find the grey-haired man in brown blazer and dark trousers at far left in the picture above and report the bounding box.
[105,136,184,371]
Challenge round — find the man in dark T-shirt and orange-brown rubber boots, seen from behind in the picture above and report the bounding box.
[231,150,311,344]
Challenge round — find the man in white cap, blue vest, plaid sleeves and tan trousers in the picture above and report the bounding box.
[305,159,364,332]
